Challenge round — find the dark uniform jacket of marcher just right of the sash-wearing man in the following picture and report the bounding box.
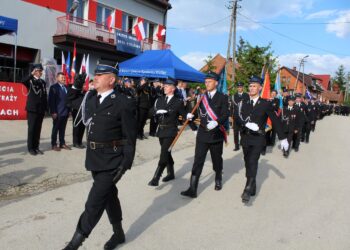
[236,98,286,146]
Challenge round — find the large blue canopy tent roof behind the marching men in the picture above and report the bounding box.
[119,50,205,82]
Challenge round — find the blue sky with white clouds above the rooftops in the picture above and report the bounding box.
[167,0,350,75]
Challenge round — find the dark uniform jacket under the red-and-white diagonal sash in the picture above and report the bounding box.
[197,91,230,143]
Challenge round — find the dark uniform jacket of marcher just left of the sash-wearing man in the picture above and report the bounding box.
[154,96,187,138]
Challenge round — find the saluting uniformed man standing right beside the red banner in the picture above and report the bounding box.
[23,63,47,155]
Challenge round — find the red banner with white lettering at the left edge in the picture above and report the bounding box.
[0,82,28,120]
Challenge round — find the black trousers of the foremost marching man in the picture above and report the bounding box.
[77,170,122,237]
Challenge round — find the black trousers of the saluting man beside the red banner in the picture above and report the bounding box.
[27,112,45,150]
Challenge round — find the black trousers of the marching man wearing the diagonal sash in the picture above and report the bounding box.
[192,139,224,178]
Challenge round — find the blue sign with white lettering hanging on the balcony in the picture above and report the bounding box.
[116,30,141,55]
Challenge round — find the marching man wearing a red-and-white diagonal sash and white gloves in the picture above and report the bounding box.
[181,72,230,198]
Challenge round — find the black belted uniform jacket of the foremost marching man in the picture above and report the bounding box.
[85,91,137,171]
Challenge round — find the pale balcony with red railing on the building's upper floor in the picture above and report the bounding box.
[53,16,170,52]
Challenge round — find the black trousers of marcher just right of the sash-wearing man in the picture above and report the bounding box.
[243,145,264,178]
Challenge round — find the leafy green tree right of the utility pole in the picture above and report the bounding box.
[236,37,277,86]
